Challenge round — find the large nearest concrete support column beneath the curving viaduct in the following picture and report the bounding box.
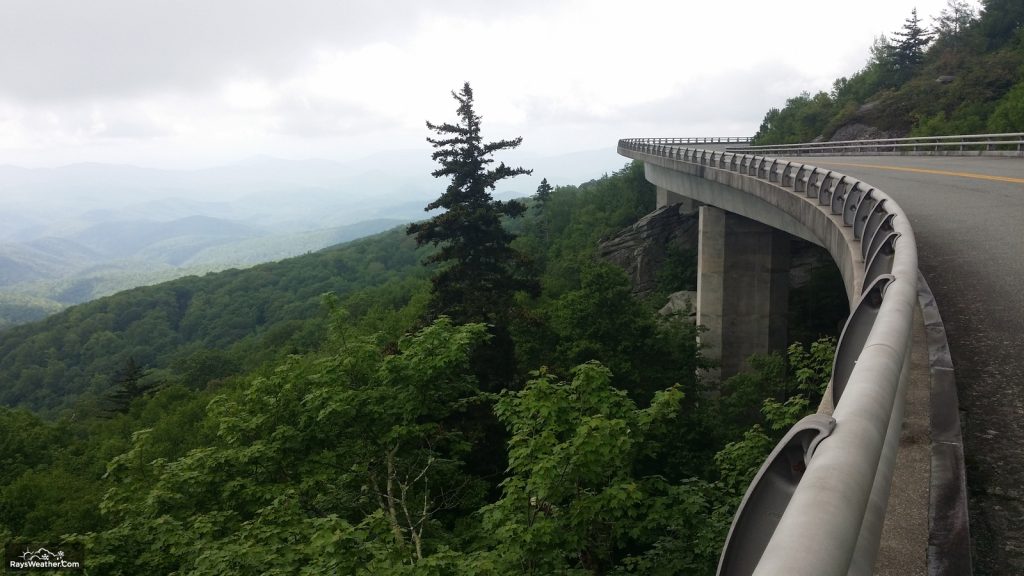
[696,206,790,378]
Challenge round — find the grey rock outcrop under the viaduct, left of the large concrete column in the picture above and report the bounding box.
[598,204,697,297]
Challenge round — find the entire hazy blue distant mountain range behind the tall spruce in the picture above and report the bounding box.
[0,149,625,329]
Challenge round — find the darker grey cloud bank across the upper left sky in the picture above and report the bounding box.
[0,0,543,101]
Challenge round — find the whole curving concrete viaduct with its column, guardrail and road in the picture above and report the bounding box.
[618,134,1024,576]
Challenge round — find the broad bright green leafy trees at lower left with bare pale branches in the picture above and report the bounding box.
[87,318,486,575]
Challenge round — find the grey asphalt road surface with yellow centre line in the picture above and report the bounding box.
[793,156,1024,575]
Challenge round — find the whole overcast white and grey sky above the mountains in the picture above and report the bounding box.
[0,0,958,168]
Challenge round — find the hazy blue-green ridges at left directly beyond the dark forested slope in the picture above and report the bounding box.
[0,216,408,329]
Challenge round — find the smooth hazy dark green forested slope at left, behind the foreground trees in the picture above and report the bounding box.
[0,229,426,412]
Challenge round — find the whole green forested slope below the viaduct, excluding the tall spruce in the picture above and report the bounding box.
[0,154,831,575]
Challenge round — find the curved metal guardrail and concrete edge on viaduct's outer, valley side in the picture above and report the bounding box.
[618,138,918,576]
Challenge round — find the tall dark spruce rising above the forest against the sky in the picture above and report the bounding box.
[408,82,538,328]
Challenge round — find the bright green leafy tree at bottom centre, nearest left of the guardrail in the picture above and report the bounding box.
[483,363,717,574]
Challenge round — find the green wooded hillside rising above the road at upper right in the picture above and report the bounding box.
[755,0,1024,145]
